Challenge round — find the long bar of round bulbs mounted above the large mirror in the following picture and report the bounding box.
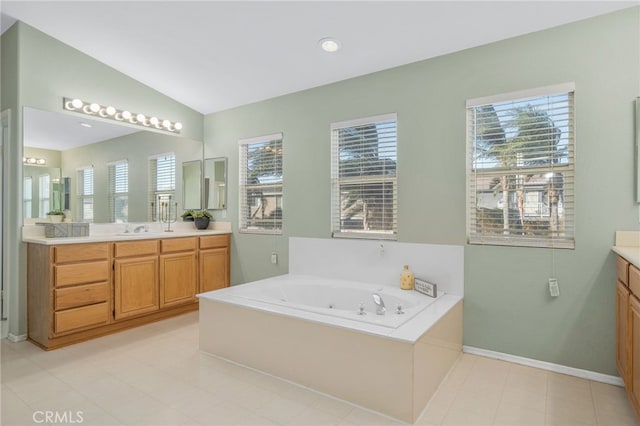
[63,98,182,133]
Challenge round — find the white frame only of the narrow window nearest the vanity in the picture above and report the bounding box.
[238,133,285,235]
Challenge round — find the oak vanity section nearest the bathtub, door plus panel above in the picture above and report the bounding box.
[198,235,230,293]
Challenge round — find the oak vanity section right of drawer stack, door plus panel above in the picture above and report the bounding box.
[113,240,160,320]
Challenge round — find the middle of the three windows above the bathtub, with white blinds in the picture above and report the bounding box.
[331,114,398,239]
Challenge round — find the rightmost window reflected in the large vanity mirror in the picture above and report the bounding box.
[149,152,177,221]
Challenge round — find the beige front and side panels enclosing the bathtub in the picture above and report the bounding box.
[199,298,462,423]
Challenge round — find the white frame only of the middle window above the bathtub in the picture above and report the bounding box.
[330,113,398,241]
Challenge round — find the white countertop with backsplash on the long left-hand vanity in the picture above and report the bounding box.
[22,221,231,245]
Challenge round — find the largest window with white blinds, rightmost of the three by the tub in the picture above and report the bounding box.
[467,84,575,248]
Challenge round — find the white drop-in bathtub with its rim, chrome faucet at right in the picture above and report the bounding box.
[218,275,444,329]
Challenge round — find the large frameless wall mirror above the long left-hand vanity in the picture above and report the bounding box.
[23,107,203,223]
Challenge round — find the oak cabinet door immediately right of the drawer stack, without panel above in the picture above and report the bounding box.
[114,256,159,319]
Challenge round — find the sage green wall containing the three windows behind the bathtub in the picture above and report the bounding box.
[204,7,640,375]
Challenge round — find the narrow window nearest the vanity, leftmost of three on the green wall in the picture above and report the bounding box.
[239,133,283,234]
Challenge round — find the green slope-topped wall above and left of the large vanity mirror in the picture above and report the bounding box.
[0,22,203,338]
